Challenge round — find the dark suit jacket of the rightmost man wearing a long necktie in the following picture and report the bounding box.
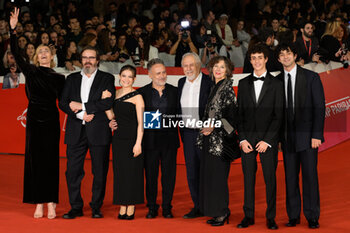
[278,66,326,152]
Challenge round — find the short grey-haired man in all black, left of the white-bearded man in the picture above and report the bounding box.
[138,58,180,218]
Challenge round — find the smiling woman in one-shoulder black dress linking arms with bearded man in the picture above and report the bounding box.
[102,65,144,220]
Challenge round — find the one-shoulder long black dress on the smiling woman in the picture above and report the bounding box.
[112,91,144,205]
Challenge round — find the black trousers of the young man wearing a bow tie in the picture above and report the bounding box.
[242,146,278,219]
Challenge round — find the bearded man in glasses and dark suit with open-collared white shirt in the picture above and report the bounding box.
[59,47,115,219]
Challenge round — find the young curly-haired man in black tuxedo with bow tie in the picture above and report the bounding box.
[237,44,283,229]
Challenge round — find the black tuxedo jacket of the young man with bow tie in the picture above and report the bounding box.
[237,73,284,147]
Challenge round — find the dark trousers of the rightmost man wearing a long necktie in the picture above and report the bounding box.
[283,147,320,220]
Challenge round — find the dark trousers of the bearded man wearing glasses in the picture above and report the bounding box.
[66,126,110,209]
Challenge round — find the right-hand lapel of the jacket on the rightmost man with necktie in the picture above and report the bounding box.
[294,66,307,116]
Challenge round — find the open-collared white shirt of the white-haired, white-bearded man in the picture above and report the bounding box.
[180,73,202,128]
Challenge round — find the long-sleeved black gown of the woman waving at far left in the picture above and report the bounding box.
[11,34,65,203]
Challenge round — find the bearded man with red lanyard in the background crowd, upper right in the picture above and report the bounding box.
[295,22,320,65]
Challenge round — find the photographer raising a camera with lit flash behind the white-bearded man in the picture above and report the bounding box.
[169,21,198,67]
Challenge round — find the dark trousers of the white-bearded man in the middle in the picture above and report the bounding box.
[183,129,201,209]
